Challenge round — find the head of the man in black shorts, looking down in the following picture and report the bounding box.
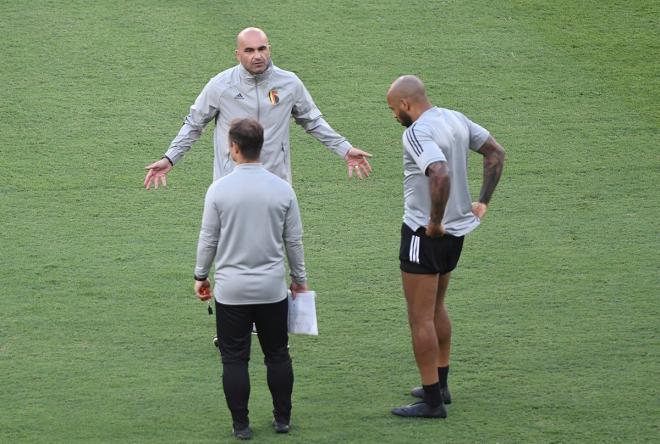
[387,75,431,127]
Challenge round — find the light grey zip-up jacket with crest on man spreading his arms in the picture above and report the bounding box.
[165,63,352,183]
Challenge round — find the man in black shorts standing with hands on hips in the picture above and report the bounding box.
[387,75,504,418]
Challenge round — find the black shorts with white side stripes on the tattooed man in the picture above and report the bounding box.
[399,223,465,274]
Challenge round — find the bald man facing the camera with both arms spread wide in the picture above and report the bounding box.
[144,28,371,188]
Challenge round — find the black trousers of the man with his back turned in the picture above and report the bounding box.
[215,298,293,428]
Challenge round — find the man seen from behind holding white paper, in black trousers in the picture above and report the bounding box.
[195,118,307,439]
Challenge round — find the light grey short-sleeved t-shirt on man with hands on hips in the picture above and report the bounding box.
[403,107,490,236]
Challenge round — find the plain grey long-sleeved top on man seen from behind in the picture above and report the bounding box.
[195,163,307,305]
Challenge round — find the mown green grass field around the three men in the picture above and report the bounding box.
[0,0,660,443]
